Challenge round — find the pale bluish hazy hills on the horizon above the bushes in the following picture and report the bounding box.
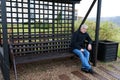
[88,16,120,26]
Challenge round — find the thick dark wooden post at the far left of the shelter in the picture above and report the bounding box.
[1,0,10,80]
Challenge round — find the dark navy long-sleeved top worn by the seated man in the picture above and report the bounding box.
[71,30,92,49]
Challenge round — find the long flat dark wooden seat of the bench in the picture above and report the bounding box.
[15,53,75,64]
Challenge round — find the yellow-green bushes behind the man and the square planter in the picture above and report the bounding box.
[75,20,120,41]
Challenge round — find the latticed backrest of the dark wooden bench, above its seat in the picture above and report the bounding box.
[9,34,71,56]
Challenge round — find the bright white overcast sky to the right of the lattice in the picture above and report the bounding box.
[75,0,120,17]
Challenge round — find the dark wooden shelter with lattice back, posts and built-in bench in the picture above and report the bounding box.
[0,0,101,80]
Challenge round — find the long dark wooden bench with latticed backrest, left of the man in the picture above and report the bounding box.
[9,34,74,79]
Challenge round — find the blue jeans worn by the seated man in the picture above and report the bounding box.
[73,49,91,69]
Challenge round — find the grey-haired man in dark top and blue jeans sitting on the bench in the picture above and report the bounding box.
[71,24,93,74]
